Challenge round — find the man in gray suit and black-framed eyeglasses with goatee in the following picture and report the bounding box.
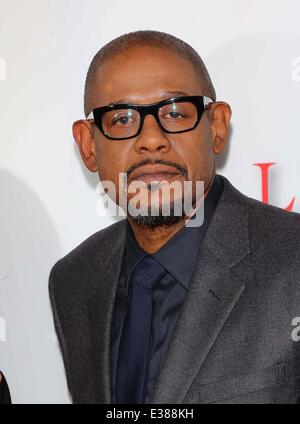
[49,31,300,403]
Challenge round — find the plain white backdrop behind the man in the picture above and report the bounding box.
[0,0,300,403]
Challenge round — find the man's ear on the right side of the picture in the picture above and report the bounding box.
[210,102,231,155]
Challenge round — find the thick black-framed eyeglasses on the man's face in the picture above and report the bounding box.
[86,96,213,140]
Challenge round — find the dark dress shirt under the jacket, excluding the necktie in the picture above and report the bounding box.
[111,174,223,403]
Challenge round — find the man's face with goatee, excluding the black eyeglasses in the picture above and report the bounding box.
[72,46,230,225]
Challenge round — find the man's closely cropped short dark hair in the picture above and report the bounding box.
[84,30,216,116]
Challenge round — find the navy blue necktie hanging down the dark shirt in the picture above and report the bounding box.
[116,255,166,403]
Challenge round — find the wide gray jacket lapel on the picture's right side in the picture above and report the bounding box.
[151,177,252,403]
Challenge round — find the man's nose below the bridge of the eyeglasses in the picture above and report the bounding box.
[134,115,171,153]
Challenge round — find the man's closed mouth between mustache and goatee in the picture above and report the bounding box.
[130,165,181,183]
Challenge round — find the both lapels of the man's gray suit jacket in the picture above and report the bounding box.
[88,176,252,403]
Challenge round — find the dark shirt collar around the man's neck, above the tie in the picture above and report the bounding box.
[124,174,223,296]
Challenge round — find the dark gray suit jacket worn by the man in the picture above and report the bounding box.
[49,177,300,403]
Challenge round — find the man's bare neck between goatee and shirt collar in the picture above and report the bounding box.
[127,174,215,254]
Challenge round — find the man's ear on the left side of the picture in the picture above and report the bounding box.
[72,119,98,172]
